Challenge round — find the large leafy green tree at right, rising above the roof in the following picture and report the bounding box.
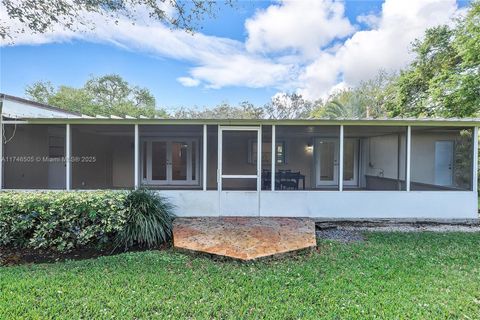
[387,1,480,117]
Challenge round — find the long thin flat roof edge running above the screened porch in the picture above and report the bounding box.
[6,118,480,127]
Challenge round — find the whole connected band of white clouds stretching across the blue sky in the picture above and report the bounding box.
[0,0,461,99]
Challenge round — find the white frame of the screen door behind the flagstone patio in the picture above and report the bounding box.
[217,125,262,215]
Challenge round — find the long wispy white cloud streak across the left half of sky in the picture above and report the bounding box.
[2,3,290,88]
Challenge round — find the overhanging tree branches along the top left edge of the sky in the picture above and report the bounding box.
[0,0,233,39]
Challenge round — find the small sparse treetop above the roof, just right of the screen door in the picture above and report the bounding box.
[264,93,314,119]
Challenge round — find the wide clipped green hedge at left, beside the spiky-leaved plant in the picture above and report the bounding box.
[0,191,127,252]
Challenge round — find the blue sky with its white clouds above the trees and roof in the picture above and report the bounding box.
[0,0,465,109]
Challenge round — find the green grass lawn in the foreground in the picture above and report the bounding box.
[0,233,480,319]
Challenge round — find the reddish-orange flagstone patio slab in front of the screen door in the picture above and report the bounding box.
[173,217,316,260]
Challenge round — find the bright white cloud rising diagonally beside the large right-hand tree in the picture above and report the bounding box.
[300,0,458,99]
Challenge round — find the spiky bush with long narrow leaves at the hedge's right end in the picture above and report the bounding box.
[116,189,174,248]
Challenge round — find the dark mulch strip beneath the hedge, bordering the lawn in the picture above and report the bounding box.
[0,244,169,266]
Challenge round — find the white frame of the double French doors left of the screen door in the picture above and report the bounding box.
[141,137,200,186]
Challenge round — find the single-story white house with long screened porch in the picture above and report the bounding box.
[0,95,480,219]
